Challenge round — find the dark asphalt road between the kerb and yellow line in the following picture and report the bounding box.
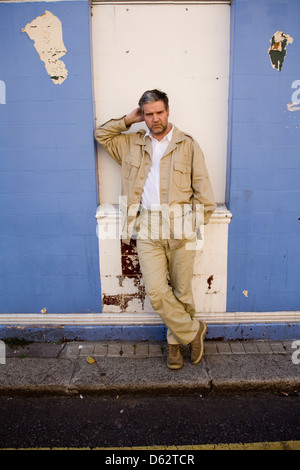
[0,394,300,449]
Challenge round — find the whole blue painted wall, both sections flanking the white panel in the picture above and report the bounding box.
[0,0,300,324]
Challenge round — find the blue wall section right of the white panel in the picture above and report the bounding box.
[227,0,300,311]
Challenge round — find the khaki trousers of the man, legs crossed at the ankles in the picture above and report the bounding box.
[137,210,199,344]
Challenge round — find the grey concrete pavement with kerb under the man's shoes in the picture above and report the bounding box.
[0,340,300,395]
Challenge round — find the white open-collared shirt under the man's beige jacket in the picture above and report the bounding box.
[142,126,173,210]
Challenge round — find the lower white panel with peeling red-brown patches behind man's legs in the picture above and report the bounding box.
[96,205,231,316]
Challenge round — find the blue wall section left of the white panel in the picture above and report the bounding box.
[0,1,101,313]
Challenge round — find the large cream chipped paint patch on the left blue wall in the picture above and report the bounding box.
[22,10,68,85]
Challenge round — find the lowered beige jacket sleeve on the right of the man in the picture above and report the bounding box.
[192,141,216,225]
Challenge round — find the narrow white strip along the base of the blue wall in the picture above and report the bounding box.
[0,312,300,326]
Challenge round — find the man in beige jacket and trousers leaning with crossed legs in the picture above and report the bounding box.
[95,90,215,369]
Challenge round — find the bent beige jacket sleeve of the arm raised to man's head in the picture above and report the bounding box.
[94,116,129,165]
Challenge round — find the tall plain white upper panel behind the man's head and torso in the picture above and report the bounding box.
[92,4,230,204]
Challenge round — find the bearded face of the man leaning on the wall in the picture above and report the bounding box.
[142,101,169,140]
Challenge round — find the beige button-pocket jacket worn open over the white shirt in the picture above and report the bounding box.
[95,117,215,248]
